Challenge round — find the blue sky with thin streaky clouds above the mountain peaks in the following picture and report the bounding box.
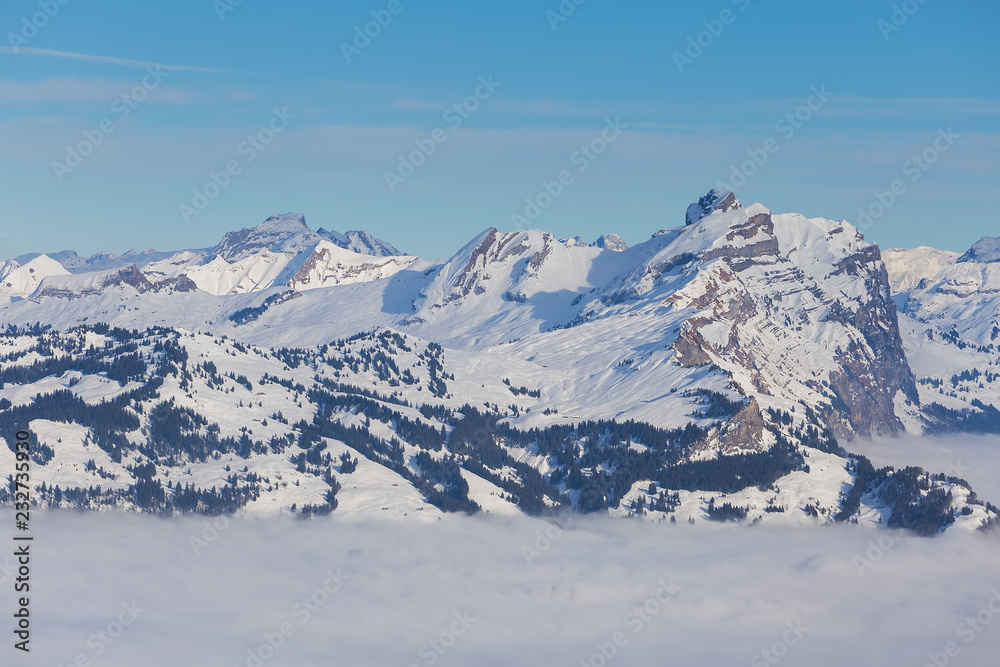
[0,0,1000,258]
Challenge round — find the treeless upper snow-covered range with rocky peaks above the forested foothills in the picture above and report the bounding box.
[0,191,940,451]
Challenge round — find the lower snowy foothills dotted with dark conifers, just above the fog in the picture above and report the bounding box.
[0,327,997,534]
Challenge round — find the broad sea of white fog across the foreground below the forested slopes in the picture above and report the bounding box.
[0,512,1000,667]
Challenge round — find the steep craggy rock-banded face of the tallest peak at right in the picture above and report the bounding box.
[630,197,918,441]
